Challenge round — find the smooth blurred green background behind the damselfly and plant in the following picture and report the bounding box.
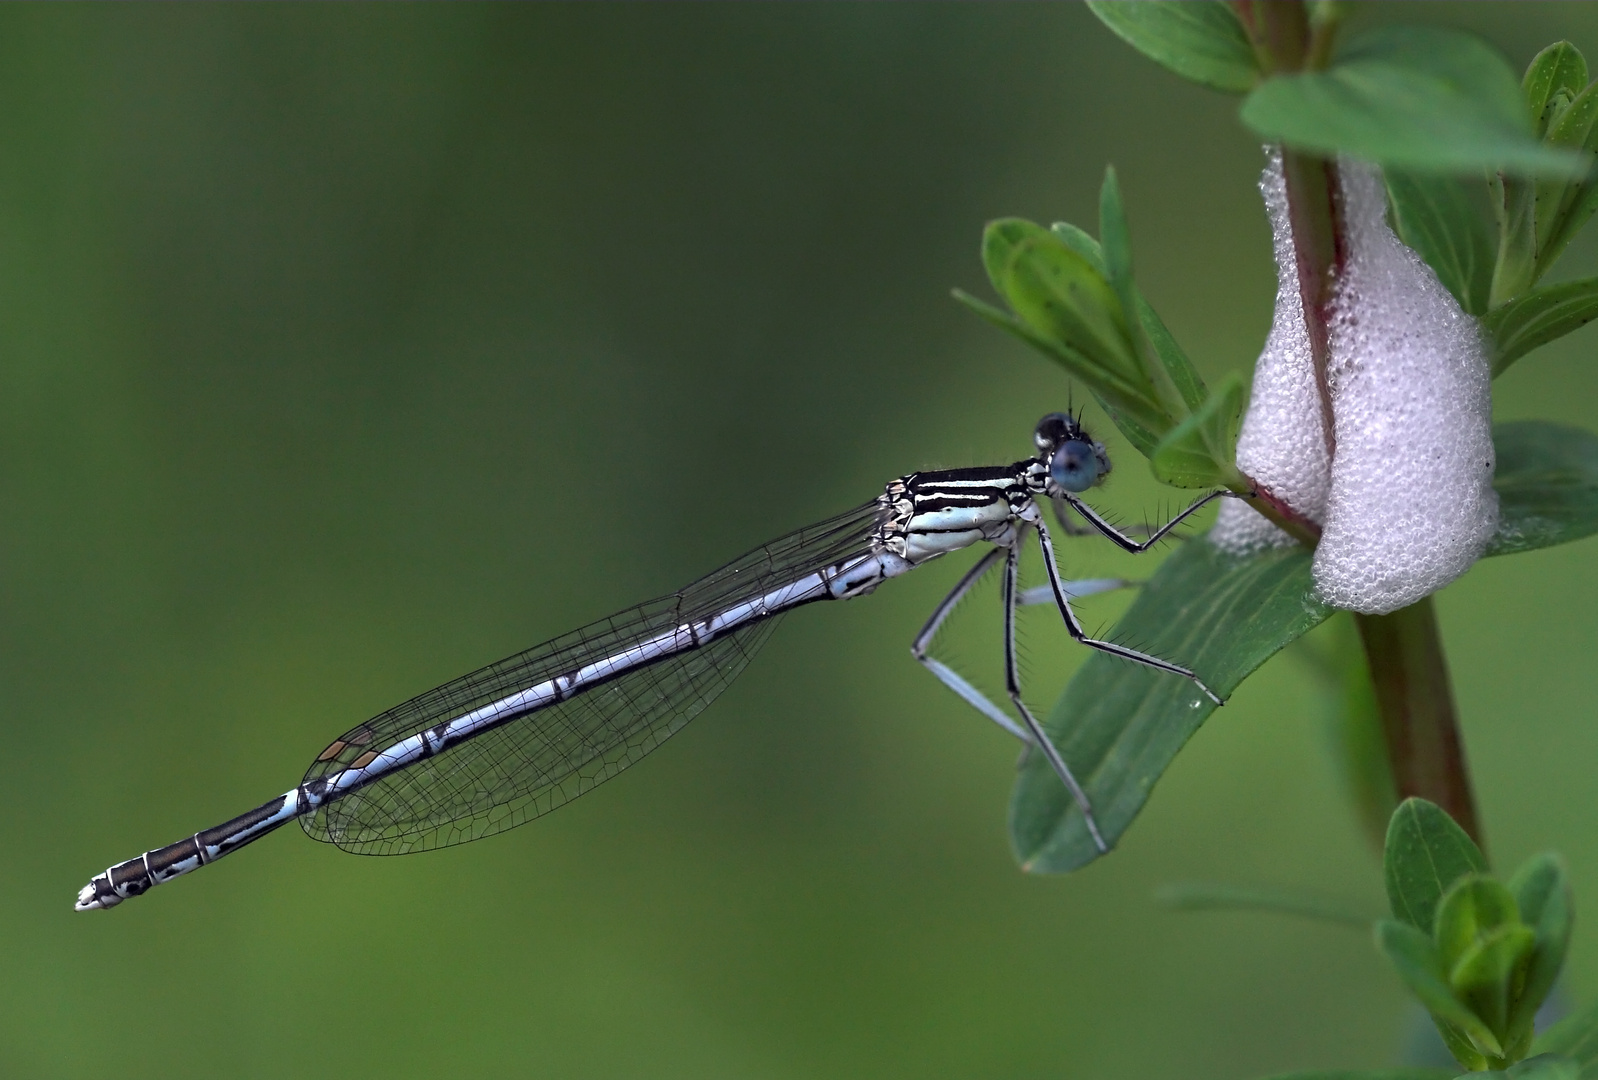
[9,3,1598,1078]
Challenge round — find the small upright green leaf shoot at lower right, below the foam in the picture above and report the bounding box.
[1376,799,1572,1069]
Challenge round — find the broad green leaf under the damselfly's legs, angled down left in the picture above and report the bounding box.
[1010,538,1331,874]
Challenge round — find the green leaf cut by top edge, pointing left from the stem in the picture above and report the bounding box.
[1088,0,1259,94]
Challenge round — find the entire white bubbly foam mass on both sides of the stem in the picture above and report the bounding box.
[1210,152,1497,613]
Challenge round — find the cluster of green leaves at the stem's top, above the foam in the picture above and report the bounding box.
[1088,0,1598,375]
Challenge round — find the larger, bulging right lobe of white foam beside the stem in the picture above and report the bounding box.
[1315,161,1497,615]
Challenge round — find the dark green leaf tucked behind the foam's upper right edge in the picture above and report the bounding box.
[1385,169,1497,315]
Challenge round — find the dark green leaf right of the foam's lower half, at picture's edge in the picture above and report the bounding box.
[1486,420,1598,554]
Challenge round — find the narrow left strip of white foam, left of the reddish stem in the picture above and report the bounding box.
[1210,149,1331,554]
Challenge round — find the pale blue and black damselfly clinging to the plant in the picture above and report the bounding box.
[77,412,1224,911]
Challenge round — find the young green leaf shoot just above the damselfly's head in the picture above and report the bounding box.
[954,169,1246,490]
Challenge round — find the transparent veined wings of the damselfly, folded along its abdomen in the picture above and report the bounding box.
[300,502,879,855]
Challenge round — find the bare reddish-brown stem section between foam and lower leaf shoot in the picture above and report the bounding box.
[1354,596,1486,850]
